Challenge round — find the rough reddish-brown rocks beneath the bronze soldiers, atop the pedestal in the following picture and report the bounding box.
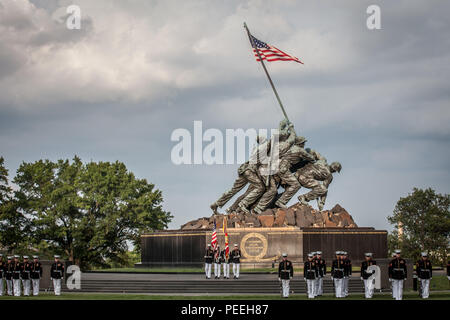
[181,203,358,230]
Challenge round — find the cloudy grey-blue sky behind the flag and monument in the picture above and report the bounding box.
[0,0,450,229]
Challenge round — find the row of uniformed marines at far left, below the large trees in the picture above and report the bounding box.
[0,254,64,297]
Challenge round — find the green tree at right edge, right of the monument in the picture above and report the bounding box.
[388,188,450,265]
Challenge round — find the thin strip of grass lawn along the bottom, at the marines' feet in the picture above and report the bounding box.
[0,291,450,301]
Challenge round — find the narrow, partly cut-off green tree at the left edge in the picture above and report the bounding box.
[0,157,30,253]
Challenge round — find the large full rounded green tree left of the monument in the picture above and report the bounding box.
[14,157,172,269]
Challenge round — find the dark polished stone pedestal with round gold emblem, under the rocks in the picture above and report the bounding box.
[138,226,387,268]
